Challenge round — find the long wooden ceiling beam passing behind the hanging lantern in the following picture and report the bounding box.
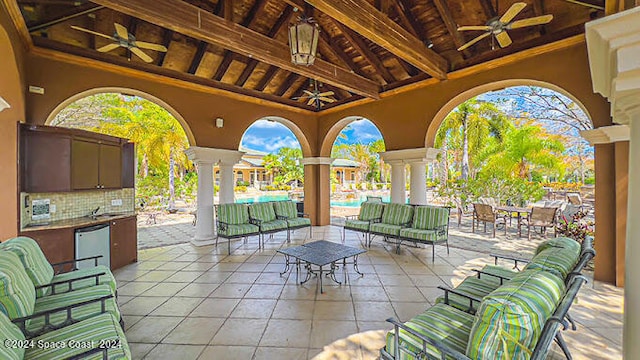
[94,0,379,99]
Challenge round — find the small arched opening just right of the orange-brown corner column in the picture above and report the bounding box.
[329,116,390,216]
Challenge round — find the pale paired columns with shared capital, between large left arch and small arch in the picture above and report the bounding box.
[185,146,244,246]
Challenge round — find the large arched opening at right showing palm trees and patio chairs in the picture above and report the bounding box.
[426,84,595,249]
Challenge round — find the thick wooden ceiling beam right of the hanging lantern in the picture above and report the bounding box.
[305,0,449,80]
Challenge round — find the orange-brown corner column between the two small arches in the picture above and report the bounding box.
[301,157,334,225]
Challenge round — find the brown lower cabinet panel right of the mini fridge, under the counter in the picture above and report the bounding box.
[110,216,138,269]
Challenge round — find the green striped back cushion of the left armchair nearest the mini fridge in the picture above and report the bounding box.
[2,236,54,296]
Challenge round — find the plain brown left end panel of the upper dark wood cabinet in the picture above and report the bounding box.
[20,131,71,192]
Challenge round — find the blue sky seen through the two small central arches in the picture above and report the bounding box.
[240,119,382,153]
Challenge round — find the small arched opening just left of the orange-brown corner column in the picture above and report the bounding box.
[234,116,310,203]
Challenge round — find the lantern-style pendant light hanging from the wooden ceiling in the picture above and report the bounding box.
[289,17,320,66]
